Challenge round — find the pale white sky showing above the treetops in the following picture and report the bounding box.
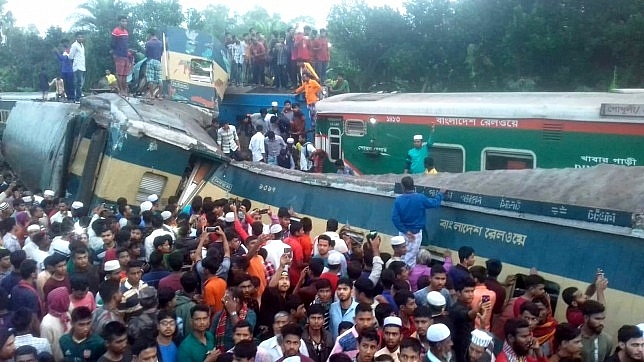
[4,0,403,34]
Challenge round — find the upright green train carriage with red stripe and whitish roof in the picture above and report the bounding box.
[316,90,644,174]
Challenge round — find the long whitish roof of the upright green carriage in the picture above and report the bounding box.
[317,89,644,123]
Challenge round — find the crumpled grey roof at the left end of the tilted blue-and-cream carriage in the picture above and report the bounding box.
[80,93,221,155]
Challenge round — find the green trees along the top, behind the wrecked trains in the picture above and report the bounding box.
[0,0,644,92]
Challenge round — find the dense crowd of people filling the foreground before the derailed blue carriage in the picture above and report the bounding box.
[0,168,644,362]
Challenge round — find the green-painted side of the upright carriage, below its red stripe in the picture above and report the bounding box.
[316,117,644,174]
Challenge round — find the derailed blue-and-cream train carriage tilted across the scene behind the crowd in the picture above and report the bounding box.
[2,94,644,331]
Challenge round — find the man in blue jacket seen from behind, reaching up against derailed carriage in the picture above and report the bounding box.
[391,176,445,268]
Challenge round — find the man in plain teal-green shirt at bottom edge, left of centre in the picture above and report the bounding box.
[179,304,221,362]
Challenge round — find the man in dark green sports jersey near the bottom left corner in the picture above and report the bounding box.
[59,307,105,362]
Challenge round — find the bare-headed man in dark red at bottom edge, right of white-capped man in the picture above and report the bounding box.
[496,318,548,362]
